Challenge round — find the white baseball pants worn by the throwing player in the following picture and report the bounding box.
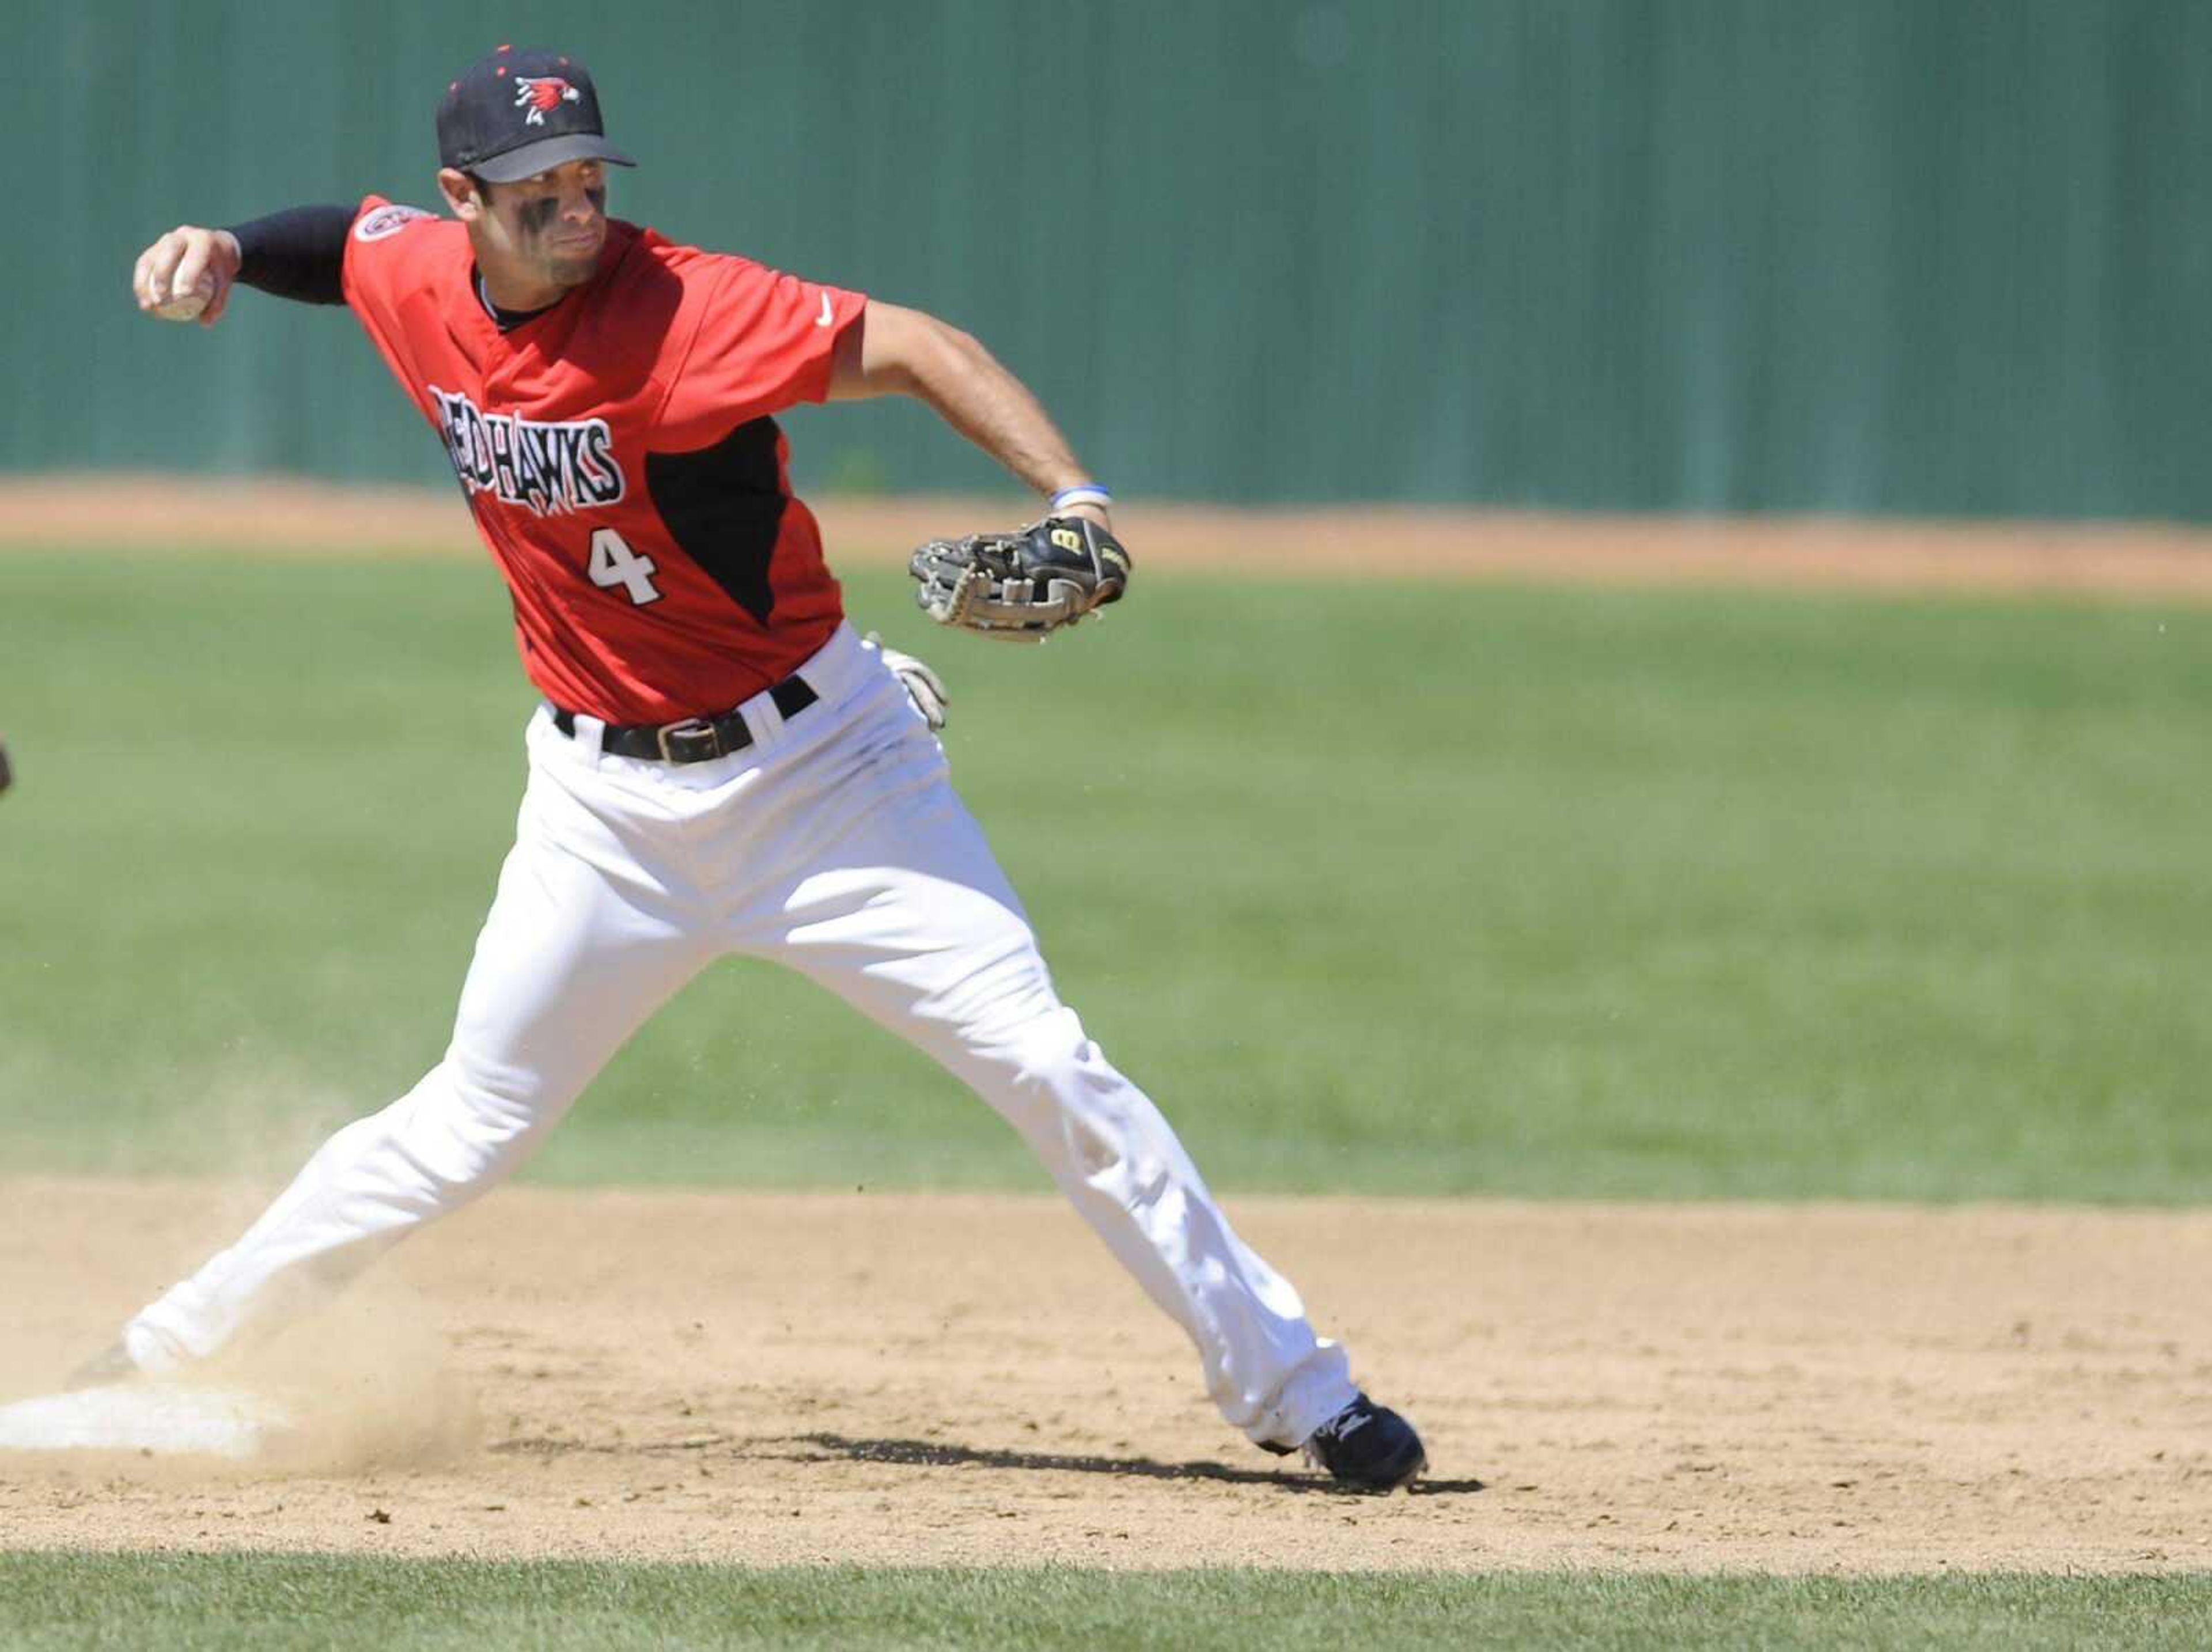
[124,626,1354,1446]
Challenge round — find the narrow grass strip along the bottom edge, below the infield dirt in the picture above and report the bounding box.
[0,1555,2212,1652]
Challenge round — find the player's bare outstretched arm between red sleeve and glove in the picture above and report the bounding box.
[830,298,1113,526]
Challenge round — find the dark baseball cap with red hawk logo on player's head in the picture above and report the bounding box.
[438,47,637,184]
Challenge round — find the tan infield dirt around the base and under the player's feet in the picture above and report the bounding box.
[0,1179,2212,1573]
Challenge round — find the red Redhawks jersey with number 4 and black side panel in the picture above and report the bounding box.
[345,195,867,723]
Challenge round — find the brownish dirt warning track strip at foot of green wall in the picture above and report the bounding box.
[13,475,2212,604]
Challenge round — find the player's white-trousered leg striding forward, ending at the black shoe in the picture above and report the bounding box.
[732,654,1356,1444]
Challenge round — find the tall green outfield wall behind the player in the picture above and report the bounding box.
[17,0,2212,517]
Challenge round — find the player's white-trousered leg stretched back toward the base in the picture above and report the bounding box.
[124,719,712,1371]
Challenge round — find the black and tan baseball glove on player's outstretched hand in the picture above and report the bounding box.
[907,516,1128,641]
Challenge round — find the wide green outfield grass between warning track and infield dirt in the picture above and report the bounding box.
[0,553,2212,1201]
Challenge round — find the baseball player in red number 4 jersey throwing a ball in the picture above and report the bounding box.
[104,47,1425,1488]
